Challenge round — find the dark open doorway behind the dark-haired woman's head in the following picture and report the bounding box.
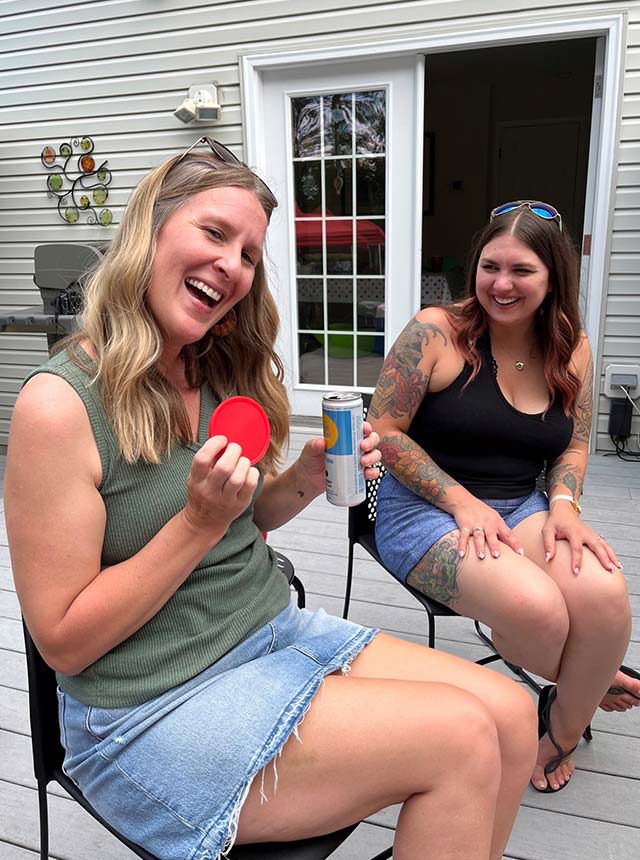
[422,39,596,305]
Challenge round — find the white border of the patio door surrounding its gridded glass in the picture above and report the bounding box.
[255,54,424,415]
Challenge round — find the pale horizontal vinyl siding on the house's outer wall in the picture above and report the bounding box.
[0,0,640,450]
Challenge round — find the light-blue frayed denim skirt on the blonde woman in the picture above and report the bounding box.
[58,601,378,860]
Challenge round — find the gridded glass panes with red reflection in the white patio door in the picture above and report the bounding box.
[291,89,387,388]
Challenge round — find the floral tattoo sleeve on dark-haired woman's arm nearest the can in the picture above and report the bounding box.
[369,318,457,504]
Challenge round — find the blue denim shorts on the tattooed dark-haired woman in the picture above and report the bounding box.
[376,472,549,582]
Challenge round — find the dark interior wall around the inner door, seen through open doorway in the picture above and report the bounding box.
[422,39,595,288]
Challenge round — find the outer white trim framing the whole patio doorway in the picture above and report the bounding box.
[239,12,626,430]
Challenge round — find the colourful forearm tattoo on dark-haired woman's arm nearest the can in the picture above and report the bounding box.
[379,433,458,505]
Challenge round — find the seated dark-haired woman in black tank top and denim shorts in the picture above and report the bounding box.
[369,201,640,791]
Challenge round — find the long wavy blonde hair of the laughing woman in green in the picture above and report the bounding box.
[65,153,289,472]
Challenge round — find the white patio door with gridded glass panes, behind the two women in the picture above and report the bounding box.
[257,55,424,415]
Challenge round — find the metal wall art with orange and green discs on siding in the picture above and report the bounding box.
[40,137,113,227]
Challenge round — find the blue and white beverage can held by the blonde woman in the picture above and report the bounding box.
[322,391,367,507]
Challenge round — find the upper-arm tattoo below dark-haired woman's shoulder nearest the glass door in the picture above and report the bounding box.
[369,319,448,418]
